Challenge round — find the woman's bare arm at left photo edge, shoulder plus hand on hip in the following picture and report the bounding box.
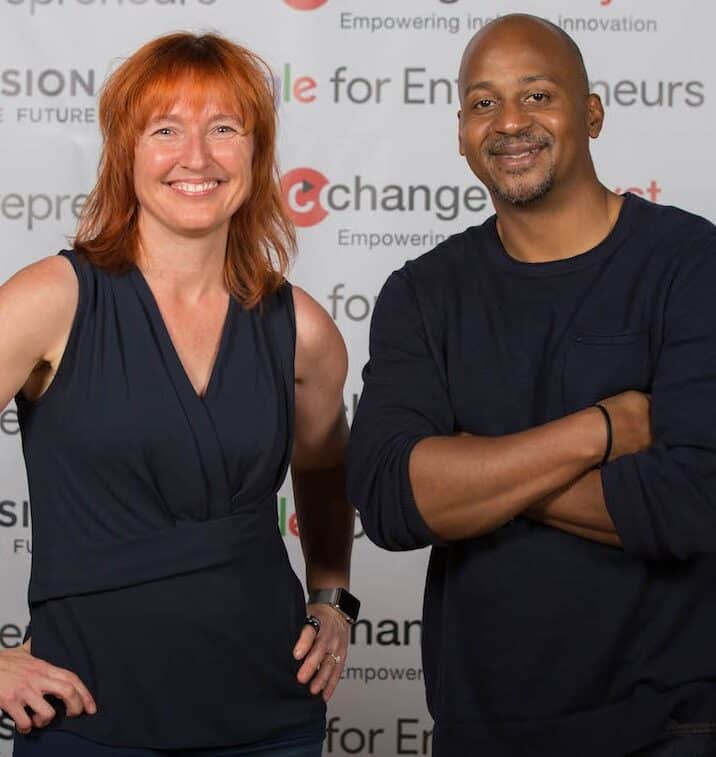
[0,256,97,733]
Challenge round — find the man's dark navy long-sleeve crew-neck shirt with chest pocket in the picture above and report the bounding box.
[348,195,716,757]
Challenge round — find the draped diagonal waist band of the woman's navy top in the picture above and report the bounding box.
[29,494,281,604]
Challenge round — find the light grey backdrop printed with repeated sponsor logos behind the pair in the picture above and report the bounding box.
[0,0,716,757]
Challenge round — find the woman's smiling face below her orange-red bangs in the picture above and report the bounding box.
[134,91,253,242]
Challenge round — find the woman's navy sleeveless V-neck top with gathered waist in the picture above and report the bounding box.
[17,251,325,749]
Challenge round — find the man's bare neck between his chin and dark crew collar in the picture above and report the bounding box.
[494,181,623,263]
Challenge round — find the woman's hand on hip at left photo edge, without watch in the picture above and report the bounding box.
[0,642,97,733]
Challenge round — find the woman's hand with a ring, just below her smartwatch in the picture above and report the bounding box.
[293,604,350,702]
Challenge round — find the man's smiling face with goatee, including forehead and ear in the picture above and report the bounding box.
[459,22,601,206]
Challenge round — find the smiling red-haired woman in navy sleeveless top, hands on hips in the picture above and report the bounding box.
[0,34,355,757]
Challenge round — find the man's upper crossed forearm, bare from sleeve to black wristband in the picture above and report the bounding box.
[409,408,605,539]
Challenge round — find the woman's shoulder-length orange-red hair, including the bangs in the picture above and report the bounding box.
[74,32,296,307]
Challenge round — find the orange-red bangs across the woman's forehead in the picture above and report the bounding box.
[129,65,257,134]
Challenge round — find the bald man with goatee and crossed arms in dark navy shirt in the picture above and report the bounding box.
[349,15,716,757]
